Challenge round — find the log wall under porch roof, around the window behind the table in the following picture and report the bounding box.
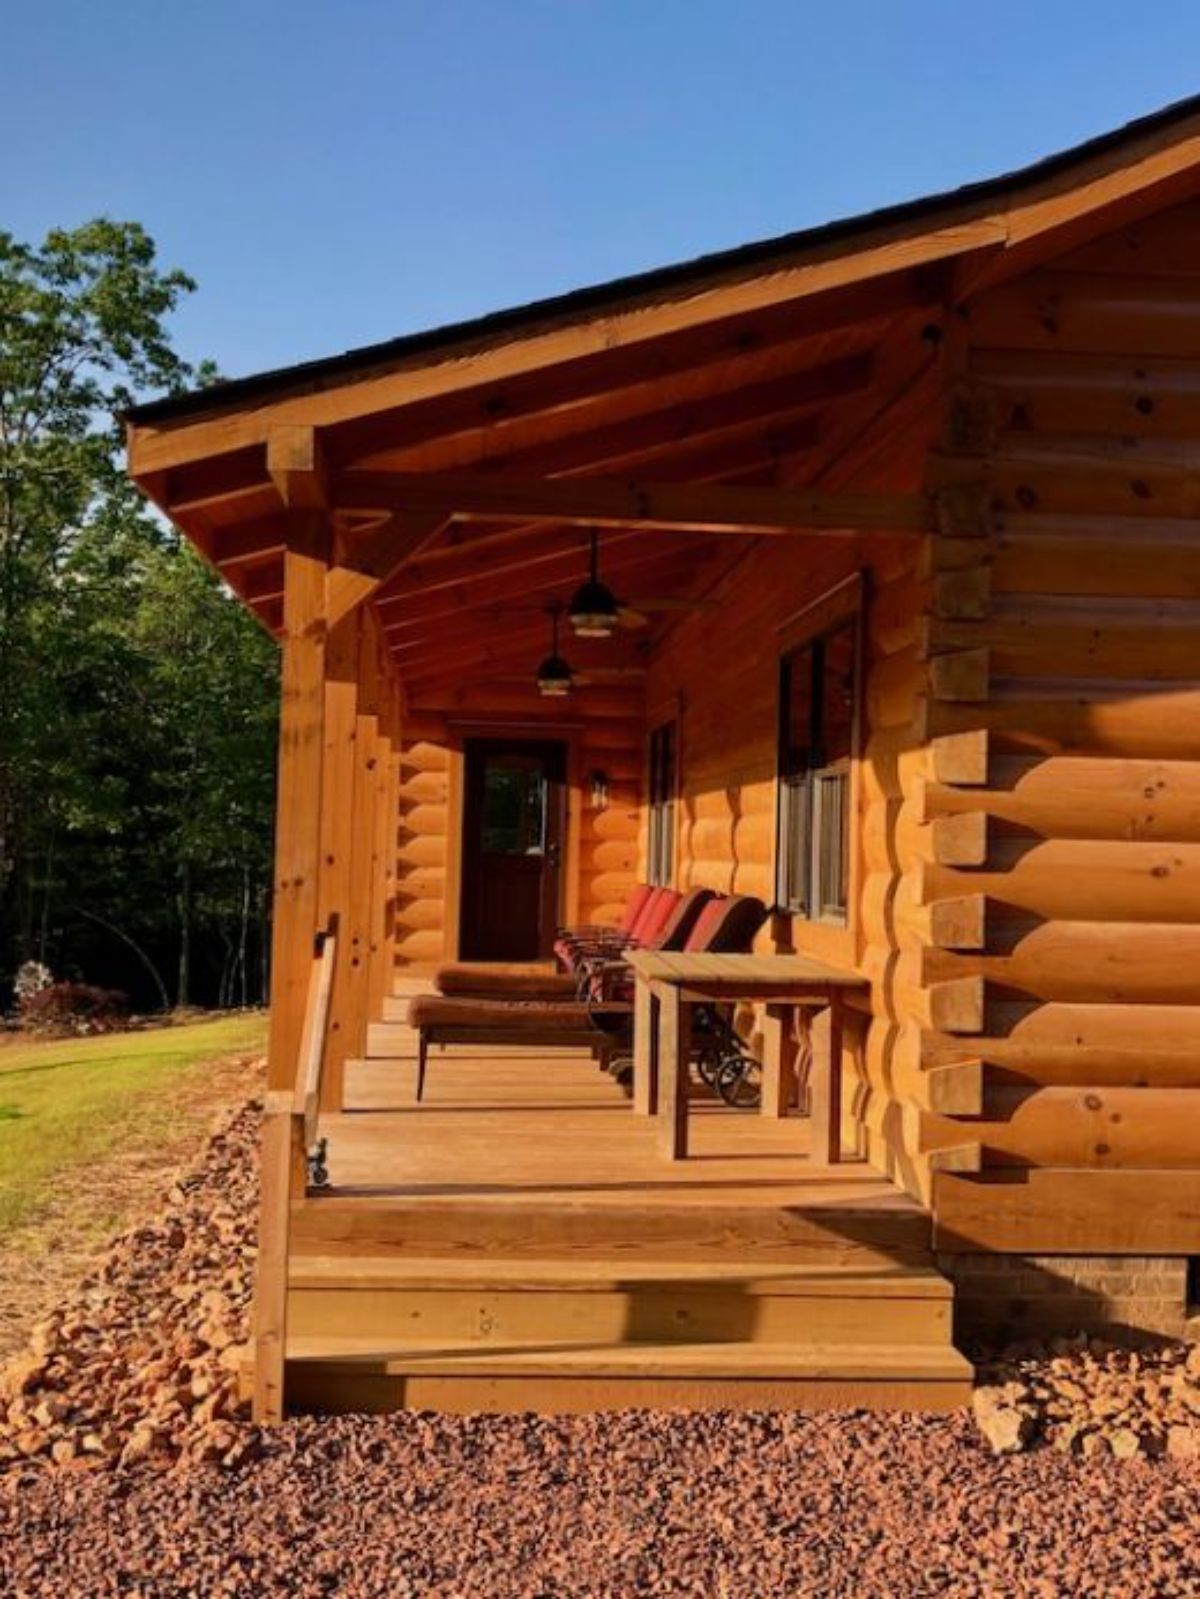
[648,361,947,1188]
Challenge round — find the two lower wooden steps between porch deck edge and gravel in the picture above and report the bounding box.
[270,1234,971,1410]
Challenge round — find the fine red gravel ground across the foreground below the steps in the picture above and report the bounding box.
[0,1412,1200,1599]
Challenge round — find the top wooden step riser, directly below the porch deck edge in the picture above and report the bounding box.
[291,1196,930,1268]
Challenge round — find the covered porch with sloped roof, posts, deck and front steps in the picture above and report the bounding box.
[124,175,998,1418]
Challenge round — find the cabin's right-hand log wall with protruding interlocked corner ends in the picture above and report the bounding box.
[921,205,1200,1252]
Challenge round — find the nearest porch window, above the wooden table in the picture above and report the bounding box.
[776,616,859,921]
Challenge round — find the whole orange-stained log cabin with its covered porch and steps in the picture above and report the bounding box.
[128,101,1200,1418]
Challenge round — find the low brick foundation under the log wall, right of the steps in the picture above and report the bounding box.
[938,1254,1195,1343]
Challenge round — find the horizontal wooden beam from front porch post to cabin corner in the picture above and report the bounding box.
[331,472,933,536]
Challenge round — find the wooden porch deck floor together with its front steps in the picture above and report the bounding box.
[262,978,971,1410]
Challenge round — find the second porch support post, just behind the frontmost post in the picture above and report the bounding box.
[320,612,358,1110]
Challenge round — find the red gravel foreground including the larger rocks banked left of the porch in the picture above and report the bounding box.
[0,1107,1200,1599]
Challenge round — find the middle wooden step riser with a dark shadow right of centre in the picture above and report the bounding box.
[288,1286,950,1348]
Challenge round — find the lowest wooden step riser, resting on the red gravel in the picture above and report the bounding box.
[286,1361,971,1415]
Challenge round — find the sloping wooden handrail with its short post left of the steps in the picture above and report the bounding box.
[254,916,338,1422]
